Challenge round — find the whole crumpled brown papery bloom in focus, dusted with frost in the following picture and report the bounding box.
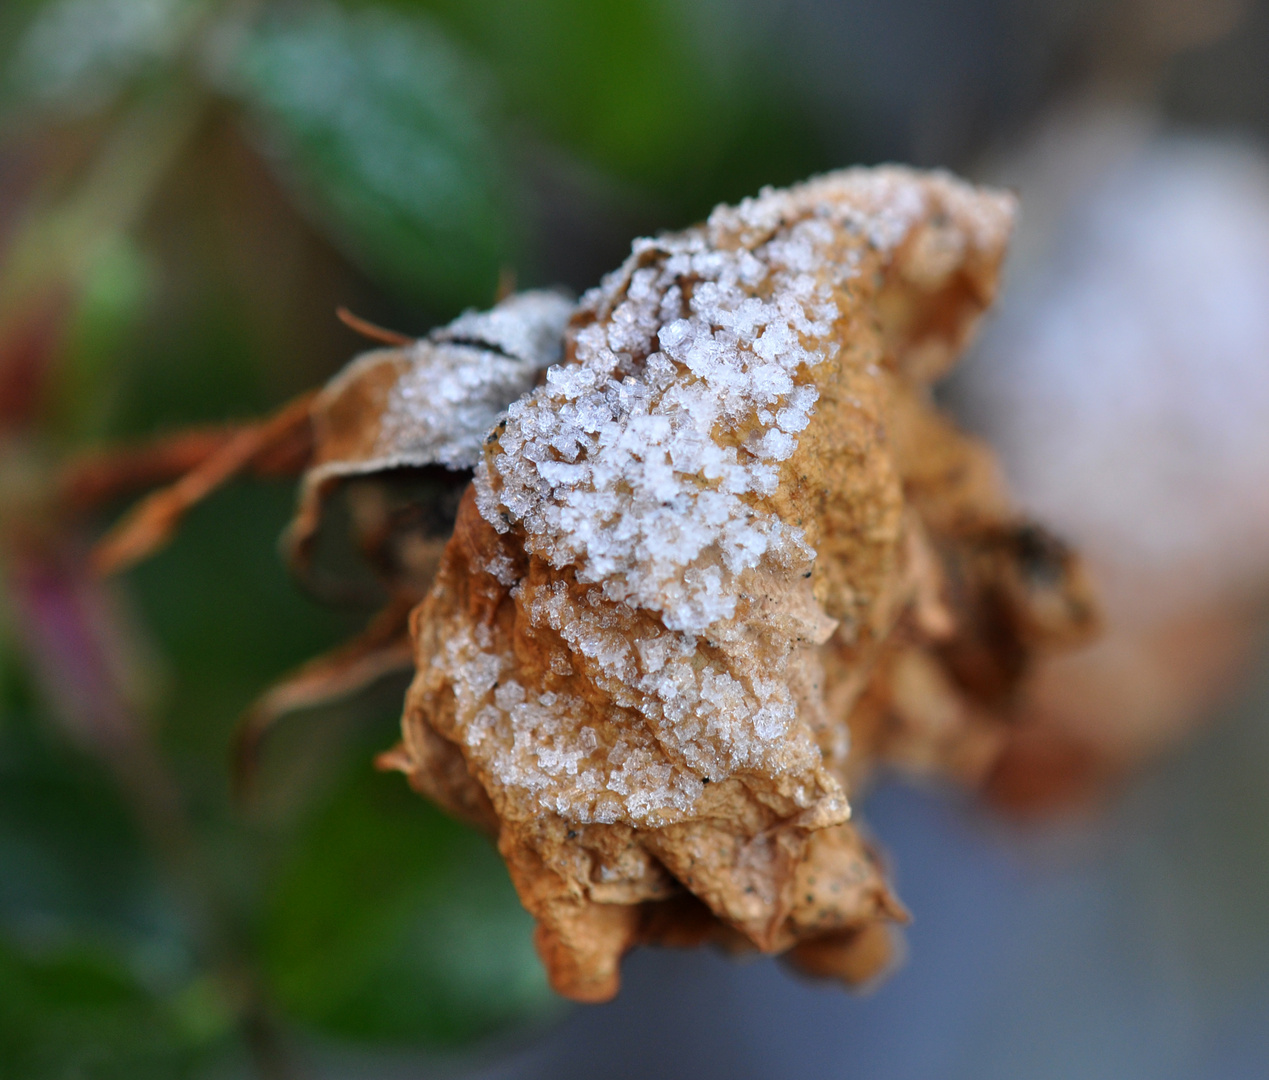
[385,169,1095,1001]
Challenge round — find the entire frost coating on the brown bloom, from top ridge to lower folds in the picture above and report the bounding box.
[443,169,1011,826]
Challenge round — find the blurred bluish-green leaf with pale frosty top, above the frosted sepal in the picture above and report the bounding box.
[230,5,515,306]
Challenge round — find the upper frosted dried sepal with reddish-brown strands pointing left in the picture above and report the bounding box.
[84,291,572,583]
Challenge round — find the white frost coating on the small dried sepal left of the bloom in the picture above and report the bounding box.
[376,292,574,468]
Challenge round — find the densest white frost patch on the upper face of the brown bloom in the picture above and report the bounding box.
[477,220,838,633]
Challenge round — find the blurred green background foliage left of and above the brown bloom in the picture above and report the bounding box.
[0,0,1269,1077]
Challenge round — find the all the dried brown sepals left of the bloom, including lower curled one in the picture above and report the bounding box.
[84,291,572,751]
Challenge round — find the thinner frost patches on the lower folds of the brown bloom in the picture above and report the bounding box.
[444,566,846,826]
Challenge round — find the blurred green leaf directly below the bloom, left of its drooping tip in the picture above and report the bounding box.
[264,761,553,1044]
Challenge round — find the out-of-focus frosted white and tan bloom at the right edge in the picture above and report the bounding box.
[950,102,1269,764]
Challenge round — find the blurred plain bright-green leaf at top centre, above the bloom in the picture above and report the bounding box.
[408,0,831,206]
